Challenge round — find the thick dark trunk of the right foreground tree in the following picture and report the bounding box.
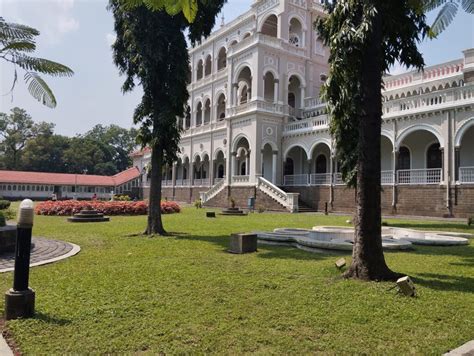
[345,14,398,281]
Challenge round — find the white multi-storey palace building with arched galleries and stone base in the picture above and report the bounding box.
[133,0,474,216]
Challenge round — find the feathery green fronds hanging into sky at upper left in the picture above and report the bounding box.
[0,17,74,108]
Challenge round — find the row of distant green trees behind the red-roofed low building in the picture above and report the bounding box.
[0,107,137,175]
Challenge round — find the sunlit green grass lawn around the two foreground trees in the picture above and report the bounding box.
[0,208,474,354]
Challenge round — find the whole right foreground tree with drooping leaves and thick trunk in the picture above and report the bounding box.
[317,0,428,280]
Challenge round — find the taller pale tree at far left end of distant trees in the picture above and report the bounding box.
[0,107,54,170]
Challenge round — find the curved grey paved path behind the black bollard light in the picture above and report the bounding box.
[0,237,81,272]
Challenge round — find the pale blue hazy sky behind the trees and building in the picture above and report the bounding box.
[0,0,474,136]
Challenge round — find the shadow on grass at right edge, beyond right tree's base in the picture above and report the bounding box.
[413,273,474,293]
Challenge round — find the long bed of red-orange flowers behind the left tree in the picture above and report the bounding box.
[35,200,181,216]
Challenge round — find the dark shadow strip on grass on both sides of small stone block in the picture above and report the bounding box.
[175,233,336,260]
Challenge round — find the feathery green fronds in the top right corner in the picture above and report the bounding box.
[424,0,474,38]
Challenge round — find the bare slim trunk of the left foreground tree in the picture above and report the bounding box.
[145,145,166,235]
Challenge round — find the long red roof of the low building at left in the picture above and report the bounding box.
[0,167,140,187]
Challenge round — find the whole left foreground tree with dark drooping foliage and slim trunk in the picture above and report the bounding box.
[109,0,225,235]
